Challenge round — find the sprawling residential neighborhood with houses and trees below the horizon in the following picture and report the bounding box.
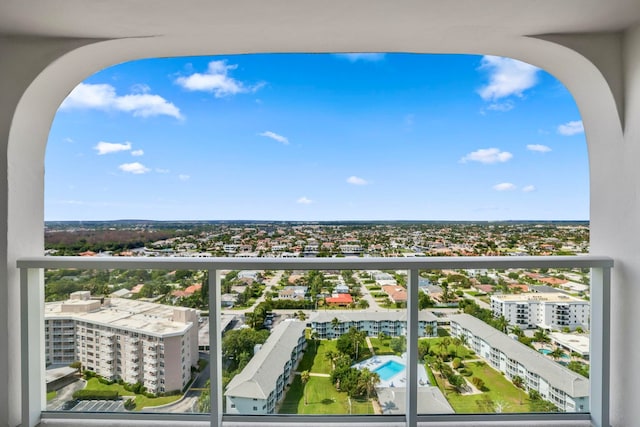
[45,223,590,414]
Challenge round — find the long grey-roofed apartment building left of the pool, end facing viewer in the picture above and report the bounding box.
[224,320,306,415]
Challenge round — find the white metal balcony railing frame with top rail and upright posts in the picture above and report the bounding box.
[18,256,613,426]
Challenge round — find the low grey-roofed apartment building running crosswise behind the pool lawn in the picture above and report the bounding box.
[311,310,438,339]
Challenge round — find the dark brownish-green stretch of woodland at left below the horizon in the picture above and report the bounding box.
[44,230,178,255]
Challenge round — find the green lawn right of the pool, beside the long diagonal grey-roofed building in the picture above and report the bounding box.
[437,362,529,414]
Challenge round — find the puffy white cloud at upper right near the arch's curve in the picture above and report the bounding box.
[478,55,539,101]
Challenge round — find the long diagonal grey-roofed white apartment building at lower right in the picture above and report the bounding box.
[450,314,589,412]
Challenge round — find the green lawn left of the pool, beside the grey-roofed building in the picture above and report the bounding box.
[279,375,373,415]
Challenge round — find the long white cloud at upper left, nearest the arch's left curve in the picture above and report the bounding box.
[60,83,182,119]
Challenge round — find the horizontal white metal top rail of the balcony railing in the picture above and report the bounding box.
[17,255,613,270]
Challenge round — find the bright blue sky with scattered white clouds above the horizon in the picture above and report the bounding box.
[45,54,589,220]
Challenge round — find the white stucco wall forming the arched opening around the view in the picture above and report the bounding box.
[0,24,640,427]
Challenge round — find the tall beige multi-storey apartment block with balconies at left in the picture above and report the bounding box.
[44,291,198,393]
